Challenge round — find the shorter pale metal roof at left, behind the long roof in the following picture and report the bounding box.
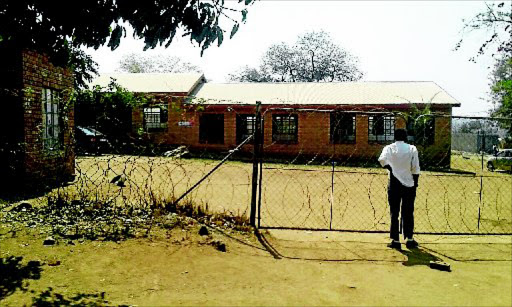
[90,73,204,94]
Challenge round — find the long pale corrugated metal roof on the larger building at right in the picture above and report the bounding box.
[191,81,460,106]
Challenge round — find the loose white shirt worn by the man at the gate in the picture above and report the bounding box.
[379,141,420,187]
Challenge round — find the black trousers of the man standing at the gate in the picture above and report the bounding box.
[388,174,416,241]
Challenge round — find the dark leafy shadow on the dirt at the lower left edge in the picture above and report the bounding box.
[0,256,42,300]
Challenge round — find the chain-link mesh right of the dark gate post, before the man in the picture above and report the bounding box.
[259,108,512,234]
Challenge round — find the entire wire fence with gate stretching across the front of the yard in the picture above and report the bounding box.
[2,100,512,234]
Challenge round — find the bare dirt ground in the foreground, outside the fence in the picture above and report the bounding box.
[0,225,512,306]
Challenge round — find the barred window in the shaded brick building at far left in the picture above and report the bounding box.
[42,88,62,150]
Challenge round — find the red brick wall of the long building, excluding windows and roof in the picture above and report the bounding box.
[134,101,451,167]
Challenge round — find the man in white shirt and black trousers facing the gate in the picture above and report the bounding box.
[379,129,420,249]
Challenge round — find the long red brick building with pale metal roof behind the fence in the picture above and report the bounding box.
[91,74,460,167]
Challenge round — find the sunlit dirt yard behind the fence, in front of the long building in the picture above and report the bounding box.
[69,156,512,234]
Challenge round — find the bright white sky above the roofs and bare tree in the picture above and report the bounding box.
[87,0,500,116]
